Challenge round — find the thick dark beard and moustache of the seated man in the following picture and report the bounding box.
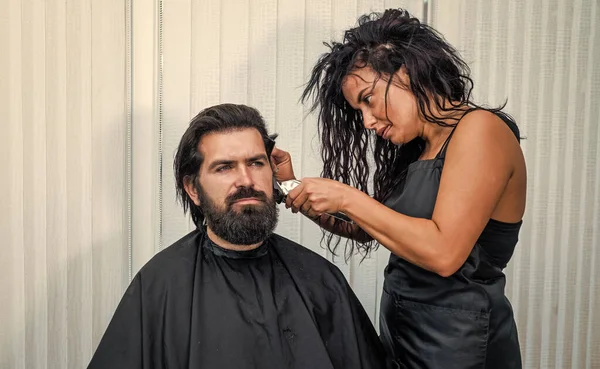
[197,186,279,245]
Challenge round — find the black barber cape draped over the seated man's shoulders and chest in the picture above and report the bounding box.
[89,230,386,369]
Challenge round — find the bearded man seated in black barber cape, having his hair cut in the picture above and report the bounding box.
[89,104,386,369]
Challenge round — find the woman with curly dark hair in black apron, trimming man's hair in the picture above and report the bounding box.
[273,10,527,369]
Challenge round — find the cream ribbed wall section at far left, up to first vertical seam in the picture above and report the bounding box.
[0,0,130,369]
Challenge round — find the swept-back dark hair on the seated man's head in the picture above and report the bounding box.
[173,104,271,227]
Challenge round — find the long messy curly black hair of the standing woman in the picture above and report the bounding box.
[301,9,502,259]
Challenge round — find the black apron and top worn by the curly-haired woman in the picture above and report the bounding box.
[380,114,521,369]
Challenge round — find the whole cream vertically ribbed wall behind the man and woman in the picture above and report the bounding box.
[0,0,600,368]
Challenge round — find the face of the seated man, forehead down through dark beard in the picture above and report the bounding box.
[192,128,278,245]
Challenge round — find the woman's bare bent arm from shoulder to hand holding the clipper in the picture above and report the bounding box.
[288,111,524,276]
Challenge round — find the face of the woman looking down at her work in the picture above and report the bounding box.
[342,66,424,145]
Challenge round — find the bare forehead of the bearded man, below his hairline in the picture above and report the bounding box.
[199,128,265,160]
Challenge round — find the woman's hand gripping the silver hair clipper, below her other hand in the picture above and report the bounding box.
[285,178,358,219]
